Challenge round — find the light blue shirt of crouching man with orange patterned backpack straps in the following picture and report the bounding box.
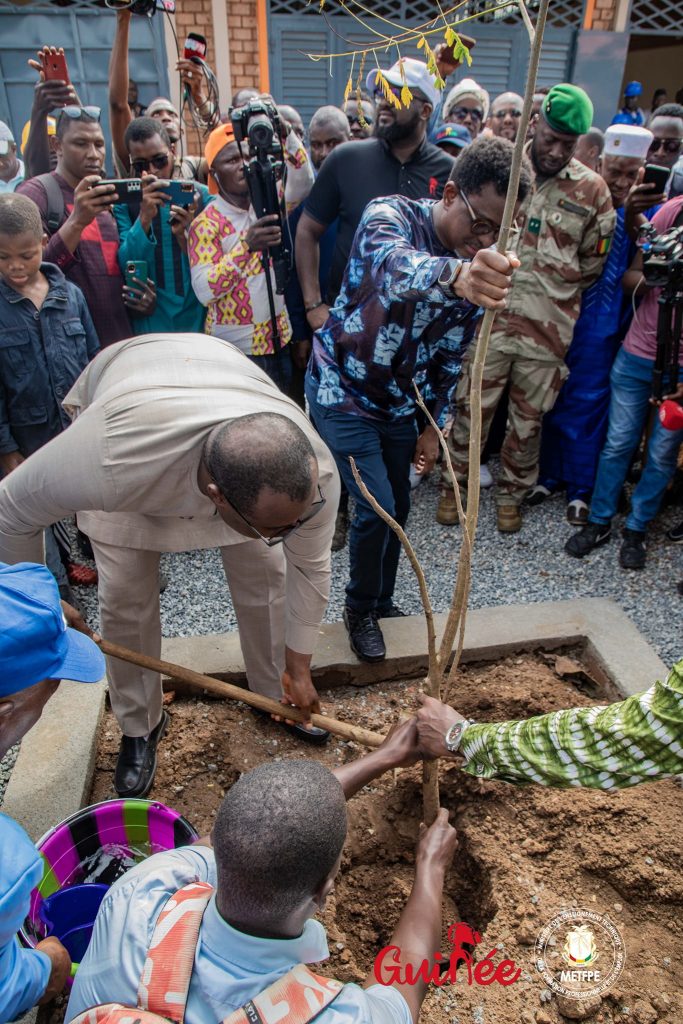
[67,846,412,1024]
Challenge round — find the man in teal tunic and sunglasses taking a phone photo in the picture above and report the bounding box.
[114,117,209,334]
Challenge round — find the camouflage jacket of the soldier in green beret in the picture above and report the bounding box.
[494,160,615,361]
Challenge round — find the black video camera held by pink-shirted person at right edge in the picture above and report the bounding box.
[638,224,683,401]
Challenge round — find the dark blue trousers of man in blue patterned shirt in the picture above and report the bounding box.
[306,387,418,614]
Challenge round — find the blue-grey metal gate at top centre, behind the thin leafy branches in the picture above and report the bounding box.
[268,0,584,122]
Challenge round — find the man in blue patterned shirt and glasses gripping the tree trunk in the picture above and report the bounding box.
[306,138,531,662]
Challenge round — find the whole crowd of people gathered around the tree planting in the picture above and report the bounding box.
[0,18,683,1024]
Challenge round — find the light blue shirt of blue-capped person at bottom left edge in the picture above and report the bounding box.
[0,814,51,1024]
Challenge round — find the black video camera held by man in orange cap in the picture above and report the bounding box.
[230,98,292,295]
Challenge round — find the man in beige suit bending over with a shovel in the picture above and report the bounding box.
[0,334,339,797]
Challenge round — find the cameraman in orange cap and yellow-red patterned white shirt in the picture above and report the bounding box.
[188,113,313,391]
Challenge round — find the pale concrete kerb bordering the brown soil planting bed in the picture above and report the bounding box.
[2,598,668,840]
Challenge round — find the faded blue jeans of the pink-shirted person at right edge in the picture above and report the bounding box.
[589,348,683,530]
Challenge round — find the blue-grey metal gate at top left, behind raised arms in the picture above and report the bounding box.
[0,0,168,151]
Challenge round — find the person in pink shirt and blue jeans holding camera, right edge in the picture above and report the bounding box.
[564,192,683,569]
